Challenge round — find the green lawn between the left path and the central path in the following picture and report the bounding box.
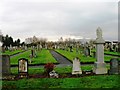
[10,49,57,65]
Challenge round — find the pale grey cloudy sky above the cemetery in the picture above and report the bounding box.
[0,0,118,41]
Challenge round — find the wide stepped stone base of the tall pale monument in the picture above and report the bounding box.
[93,62,107,74]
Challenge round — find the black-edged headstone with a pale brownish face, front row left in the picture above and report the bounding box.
[18,58,28,77]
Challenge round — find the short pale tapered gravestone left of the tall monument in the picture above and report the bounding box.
[72,58,82,74]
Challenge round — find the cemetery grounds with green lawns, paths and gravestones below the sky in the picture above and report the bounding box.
[0,28,120,89]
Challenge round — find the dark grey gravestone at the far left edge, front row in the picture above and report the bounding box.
[0,55,11,75]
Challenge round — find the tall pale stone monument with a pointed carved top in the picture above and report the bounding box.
[93,27,107,74]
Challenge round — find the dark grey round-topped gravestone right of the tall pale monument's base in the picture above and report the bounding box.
[109,58,119,74]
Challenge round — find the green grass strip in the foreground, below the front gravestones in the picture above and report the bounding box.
[2,75,120,90]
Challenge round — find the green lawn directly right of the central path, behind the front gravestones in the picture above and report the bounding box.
[56,50,119,62]
